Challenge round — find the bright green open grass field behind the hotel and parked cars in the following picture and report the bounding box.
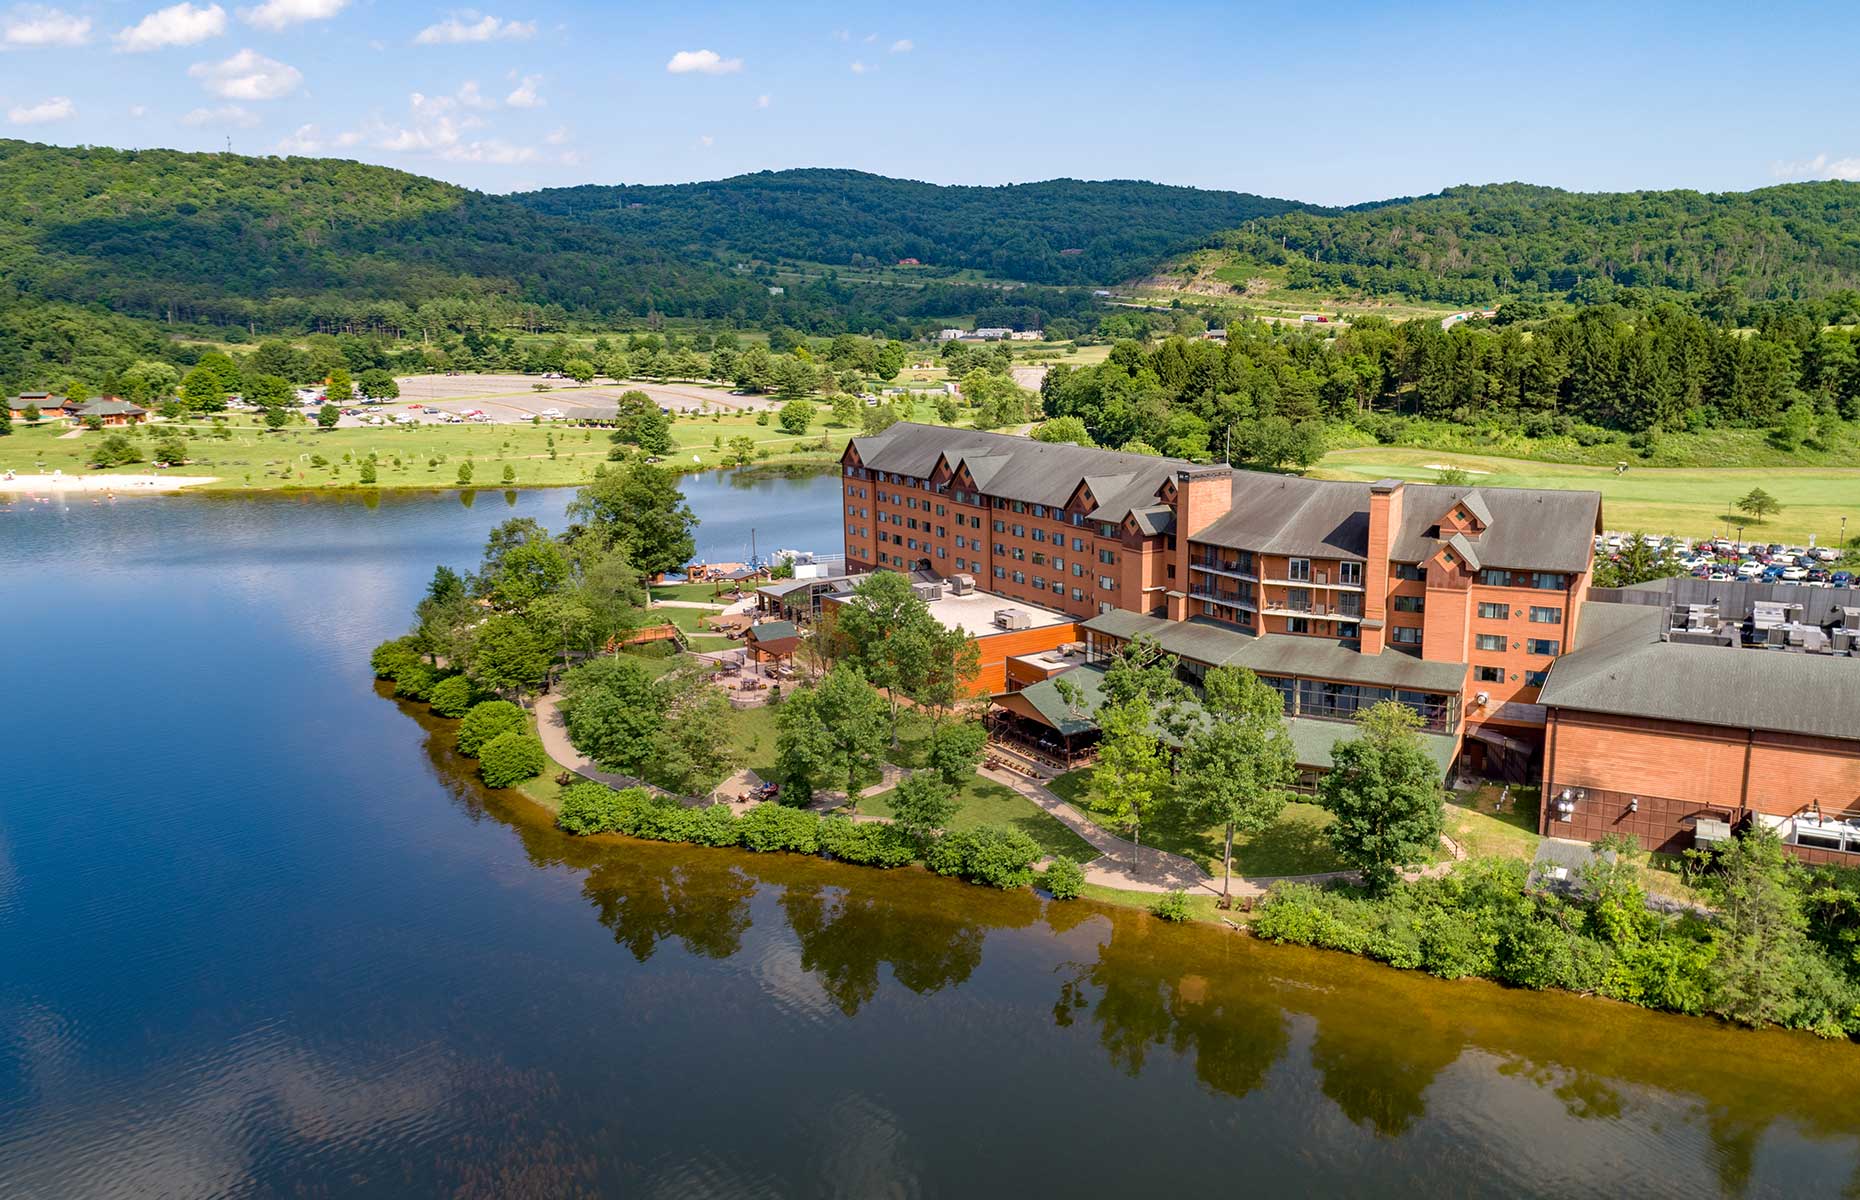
[1313,447,1860,545]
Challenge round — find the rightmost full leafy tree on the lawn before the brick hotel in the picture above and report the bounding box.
[1317,700,1445,891]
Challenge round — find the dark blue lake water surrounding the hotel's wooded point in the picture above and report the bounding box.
[0,476,1860,1198]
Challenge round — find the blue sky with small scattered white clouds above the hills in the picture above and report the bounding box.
[0,0,1860,205]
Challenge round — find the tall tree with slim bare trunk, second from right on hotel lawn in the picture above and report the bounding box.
[1179,666,1298,906]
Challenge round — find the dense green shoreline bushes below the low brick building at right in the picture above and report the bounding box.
[1252,830,1860,1038]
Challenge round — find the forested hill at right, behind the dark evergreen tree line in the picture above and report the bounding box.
[1220,182,1860,303]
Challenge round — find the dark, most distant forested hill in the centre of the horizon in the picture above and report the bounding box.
[513,169,1330,285]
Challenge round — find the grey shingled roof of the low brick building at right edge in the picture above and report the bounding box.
[1538,601,1860,740]
